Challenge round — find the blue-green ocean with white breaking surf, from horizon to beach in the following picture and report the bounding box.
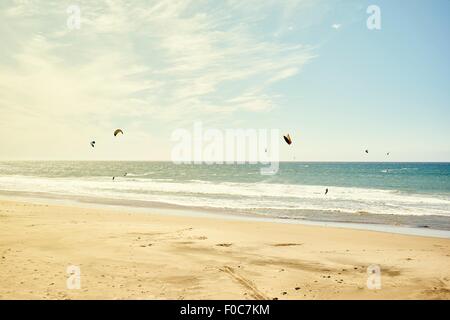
[0,161,450,230]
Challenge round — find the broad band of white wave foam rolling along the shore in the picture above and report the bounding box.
[0,176,450,216]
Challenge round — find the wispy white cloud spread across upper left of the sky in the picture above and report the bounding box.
[0,0,314,159]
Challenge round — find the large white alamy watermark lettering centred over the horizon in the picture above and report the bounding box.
[171,122,280,175]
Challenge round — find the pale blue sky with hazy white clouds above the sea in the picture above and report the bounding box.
[0,0,450,161]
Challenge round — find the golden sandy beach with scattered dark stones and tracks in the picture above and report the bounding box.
[0,201,450,299]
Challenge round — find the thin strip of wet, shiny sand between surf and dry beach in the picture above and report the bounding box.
[0,190,450,239]
